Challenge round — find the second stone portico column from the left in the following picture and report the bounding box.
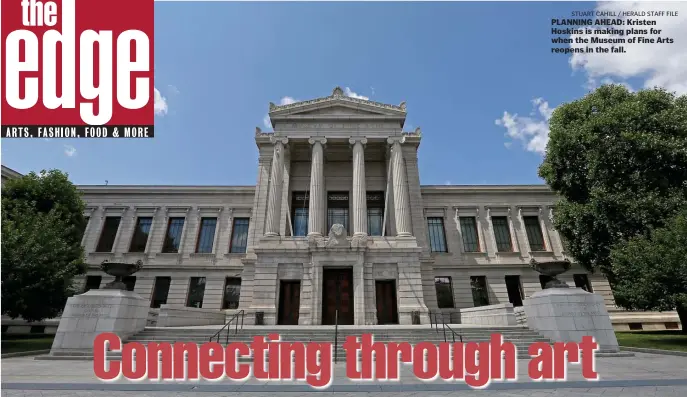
[308,138,327,237]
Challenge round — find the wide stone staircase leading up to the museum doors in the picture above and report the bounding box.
[127,324,551,362]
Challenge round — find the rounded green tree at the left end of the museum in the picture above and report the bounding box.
[2,170,86,321]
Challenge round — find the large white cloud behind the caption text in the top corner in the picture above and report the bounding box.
[570,1,687,94]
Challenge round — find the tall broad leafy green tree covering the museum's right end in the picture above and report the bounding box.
[539,85,687,324]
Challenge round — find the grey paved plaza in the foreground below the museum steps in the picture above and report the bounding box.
[2,353,687,397]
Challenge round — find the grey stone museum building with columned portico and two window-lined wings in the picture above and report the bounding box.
[3,87,678,332]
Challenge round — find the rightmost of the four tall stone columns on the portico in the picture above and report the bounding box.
[387,137,413,237]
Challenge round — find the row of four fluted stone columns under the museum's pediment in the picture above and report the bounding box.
[265,137,412,237]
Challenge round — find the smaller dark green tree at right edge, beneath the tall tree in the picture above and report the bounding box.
[611,210,687,333]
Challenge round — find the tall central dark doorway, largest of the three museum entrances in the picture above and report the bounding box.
[322,268,354,325]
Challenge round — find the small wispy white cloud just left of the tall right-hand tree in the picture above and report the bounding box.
[496,98,553,154]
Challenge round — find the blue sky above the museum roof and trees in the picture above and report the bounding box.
[2,2,687,185]
